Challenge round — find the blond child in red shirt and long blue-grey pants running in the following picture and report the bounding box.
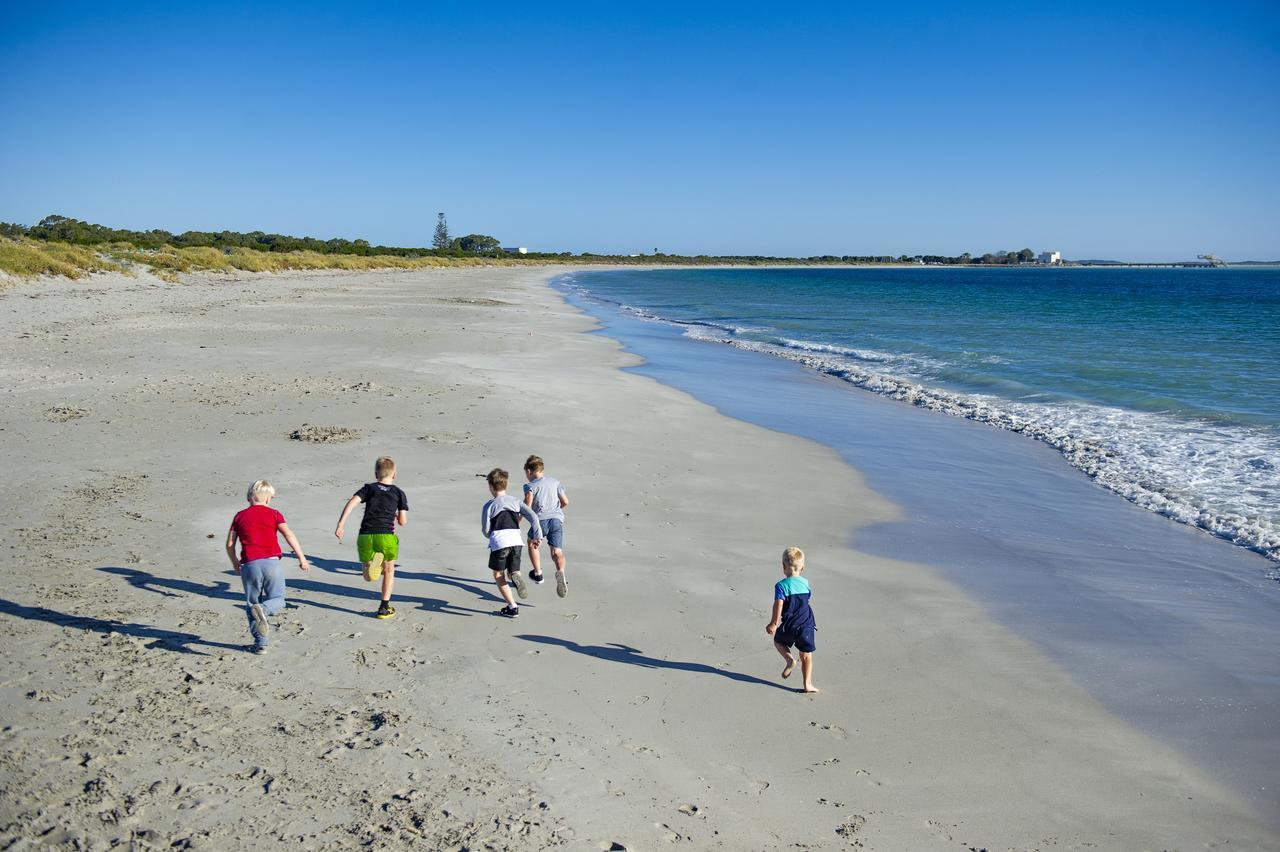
[227,480,311,654]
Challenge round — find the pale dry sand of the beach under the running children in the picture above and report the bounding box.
[0,263,1280,849]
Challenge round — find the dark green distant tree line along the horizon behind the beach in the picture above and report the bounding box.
[0,212,1054,266]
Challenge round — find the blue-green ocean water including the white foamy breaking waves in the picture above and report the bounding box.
[559,269,1280,562]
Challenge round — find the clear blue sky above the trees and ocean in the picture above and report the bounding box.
[0,1,1280,260]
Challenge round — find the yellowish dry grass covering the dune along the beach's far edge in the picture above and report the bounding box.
[0,238,560,281]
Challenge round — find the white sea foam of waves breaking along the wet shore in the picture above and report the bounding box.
[561,276,1280,562]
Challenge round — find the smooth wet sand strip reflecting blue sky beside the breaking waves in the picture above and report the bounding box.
[562,277,1280,812]
